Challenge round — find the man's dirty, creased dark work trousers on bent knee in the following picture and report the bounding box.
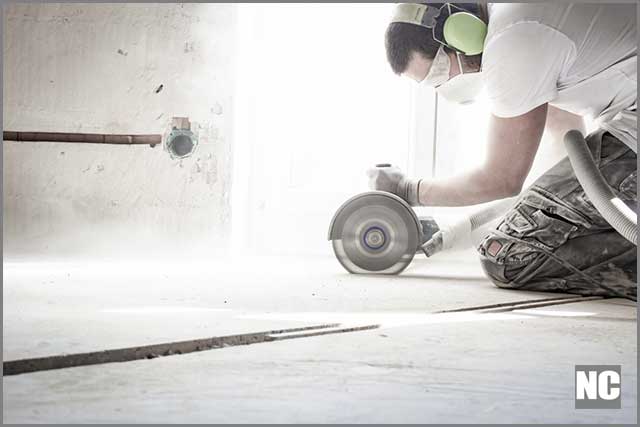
[477,130,637,298]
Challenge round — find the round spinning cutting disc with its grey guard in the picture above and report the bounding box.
[330,191,421,274]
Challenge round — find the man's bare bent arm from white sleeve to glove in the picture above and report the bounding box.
[418,103,547,206]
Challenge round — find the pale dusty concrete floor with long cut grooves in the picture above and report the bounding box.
[3,257,637,423]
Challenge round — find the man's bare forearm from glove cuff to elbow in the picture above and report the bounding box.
[419,168,521,206]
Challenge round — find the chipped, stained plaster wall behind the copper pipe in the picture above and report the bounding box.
[3,4,236,258]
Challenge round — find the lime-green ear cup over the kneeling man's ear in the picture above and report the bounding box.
[442,12,487,55]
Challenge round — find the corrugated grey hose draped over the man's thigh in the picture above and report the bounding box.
[564,130,638,246]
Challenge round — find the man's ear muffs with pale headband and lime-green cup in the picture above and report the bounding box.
[391,3,487,55]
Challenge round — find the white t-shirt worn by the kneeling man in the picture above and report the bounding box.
[482,2,638,152]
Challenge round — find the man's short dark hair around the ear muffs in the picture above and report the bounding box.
[384,3,484,74]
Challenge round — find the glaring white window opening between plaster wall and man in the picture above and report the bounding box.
[232,4,410,254]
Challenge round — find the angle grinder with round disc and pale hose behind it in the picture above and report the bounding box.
[329,186,517,274]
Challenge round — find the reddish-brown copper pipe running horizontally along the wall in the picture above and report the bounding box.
[2,131,162,147]
